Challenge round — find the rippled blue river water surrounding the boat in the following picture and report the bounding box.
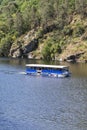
[0,59,87,130]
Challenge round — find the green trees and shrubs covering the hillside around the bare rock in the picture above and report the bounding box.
[0,0,87,59]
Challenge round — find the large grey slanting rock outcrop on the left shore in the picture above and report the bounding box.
[9,30,38,58]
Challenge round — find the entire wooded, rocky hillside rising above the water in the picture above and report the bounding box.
[0,0,87,62]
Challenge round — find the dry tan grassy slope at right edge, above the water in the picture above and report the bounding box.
[60,15,87,62]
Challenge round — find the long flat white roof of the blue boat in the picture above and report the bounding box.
[26,64,68,69]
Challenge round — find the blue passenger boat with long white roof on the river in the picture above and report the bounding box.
[26,64,70,77]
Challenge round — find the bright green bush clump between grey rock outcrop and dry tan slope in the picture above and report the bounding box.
[42,33,65,60]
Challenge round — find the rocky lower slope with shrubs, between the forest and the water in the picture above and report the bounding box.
[10,14,87,62]
